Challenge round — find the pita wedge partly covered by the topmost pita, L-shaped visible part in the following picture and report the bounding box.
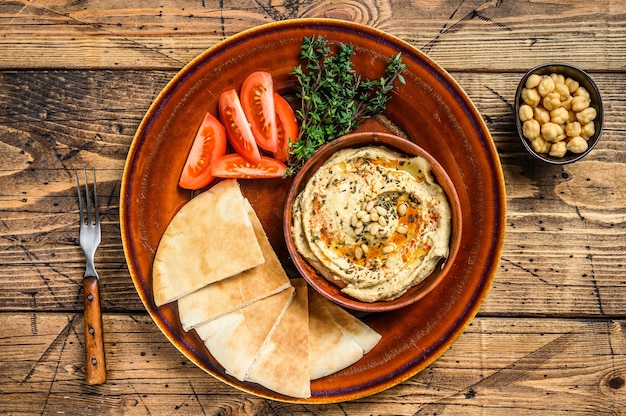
[178,199,291,331]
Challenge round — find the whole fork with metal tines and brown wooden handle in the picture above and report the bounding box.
[74,168,107,384]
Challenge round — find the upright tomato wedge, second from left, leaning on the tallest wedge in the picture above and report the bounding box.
[219,90,261,163]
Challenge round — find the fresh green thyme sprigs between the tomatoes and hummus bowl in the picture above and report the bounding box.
[287,36,406,174]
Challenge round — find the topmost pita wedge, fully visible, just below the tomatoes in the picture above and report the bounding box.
[152,179,265,306]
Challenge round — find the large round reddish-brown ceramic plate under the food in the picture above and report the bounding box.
[120,19,506,403]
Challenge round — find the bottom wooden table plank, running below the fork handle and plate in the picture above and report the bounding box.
[0,313,626,415]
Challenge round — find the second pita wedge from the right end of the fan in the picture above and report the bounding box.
[309,290,363,380]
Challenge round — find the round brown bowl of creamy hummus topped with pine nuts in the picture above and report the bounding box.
[283,132,462,312]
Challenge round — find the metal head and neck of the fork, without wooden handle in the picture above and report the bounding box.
[75,169,100,278]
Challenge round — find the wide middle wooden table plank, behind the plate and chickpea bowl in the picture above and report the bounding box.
[0,71,626,317]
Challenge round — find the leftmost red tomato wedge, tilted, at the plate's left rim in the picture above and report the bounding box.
[178,109,226,189]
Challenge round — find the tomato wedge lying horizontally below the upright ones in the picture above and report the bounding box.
[211,153,287,179]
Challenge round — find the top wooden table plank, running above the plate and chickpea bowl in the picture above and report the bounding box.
[0,0,626,71]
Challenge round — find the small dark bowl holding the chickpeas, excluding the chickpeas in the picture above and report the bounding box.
[515,63,604,165]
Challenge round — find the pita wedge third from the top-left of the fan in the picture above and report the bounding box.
[195,287,295,381]
